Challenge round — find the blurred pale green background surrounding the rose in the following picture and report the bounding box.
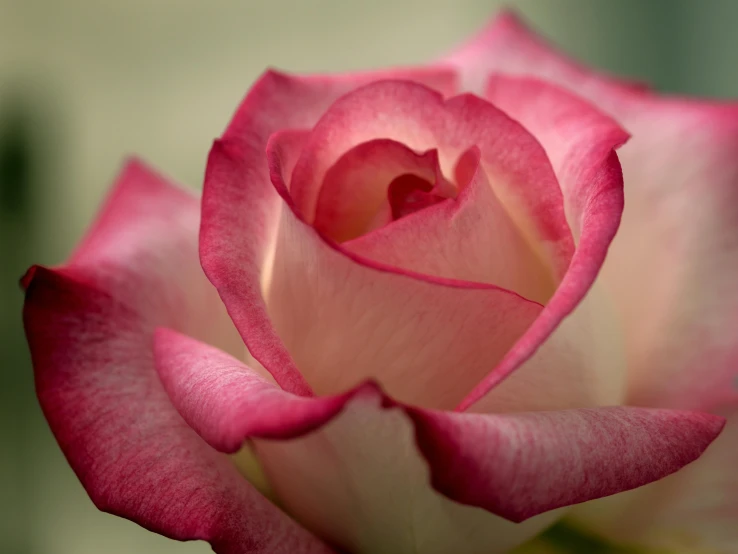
[0,0,738,554]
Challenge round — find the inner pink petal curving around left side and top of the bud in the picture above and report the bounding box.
[200,69,455,394]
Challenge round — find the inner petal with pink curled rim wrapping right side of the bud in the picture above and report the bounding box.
[462,77,628,411]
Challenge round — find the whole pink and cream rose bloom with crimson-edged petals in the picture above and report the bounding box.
[23,13,738,554]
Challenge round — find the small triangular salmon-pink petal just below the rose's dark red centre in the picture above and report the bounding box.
[344,147,554,303]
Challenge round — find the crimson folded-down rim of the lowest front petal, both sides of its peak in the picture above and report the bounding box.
[155,329,725,532]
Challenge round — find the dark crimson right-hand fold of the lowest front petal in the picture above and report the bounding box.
[414,406,725,521]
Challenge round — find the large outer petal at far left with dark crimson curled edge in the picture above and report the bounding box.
[24,162,331,554]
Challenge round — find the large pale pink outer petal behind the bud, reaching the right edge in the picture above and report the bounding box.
[458,8,738,418]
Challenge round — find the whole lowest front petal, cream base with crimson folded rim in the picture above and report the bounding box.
[156,331,723,554]
